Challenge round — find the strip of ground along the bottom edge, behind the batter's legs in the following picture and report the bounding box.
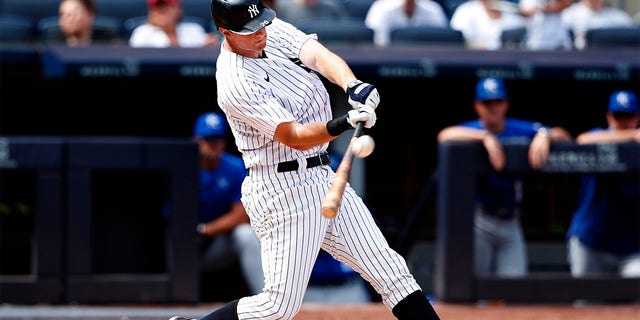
[0,302,640,320]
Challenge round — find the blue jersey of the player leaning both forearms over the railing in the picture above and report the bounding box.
[460,118,543,207]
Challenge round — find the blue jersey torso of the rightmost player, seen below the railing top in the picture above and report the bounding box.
[567,130,640,255]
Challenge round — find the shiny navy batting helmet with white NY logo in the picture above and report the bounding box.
[211,0,276,34]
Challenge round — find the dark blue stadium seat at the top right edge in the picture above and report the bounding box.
[585,26,640,49]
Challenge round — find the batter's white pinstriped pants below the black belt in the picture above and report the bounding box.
[238,166,420,319]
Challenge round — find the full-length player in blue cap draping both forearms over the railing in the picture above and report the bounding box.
[438,78,571,276]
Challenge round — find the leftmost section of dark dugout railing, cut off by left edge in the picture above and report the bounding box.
[0,137,64,303]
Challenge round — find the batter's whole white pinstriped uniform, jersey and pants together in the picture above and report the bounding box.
[216,19,420,320]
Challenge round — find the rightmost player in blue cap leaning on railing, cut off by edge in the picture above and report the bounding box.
[567,91,640,277]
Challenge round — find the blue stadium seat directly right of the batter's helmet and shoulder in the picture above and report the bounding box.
[296,18,373,44]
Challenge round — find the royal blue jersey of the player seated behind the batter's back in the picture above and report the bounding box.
[198,153,247,223]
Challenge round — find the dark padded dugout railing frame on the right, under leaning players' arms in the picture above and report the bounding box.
[434,142,640,303]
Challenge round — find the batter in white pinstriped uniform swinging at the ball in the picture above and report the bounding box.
[172,0,439,320]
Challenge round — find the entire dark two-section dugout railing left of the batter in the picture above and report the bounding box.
[0,136,199,303]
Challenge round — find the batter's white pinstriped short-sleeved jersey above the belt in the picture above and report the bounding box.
[216,19,332,167]
